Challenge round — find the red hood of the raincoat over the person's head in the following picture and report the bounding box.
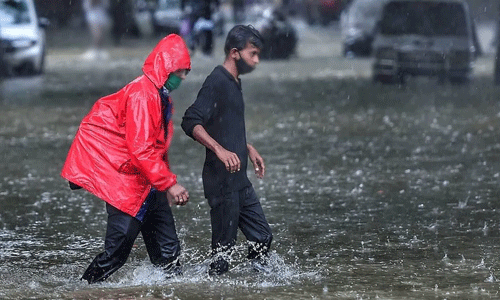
[142,34,191,89]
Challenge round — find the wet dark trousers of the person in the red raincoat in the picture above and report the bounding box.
[82,191,181,283]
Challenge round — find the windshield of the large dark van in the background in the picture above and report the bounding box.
[380,1,467,36]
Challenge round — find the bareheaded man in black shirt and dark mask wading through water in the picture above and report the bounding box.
[182,25,272,275]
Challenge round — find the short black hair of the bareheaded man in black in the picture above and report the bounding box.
[224,25,264,55]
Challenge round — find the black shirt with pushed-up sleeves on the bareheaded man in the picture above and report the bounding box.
[181,66,251,198]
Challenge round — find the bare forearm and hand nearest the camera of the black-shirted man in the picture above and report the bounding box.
[193,124,241,173]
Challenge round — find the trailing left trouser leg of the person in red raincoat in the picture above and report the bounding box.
[82,204,141,283]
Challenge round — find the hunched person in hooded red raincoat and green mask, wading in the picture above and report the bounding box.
[61,34,191,283]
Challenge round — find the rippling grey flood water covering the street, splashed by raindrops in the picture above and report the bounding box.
[0,24,500,299]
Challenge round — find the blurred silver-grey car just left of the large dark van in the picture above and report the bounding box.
[340,0,387,57]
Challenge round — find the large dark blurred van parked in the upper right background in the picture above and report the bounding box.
[373,0,477,83]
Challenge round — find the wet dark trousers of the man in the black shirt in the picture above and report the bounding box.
[208,186,273,259]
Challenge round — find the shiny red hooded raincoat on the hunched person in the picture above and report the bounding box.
[61,34,191,216]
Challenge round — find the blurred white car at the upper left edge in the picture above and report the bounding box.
[0,0,48,75]
